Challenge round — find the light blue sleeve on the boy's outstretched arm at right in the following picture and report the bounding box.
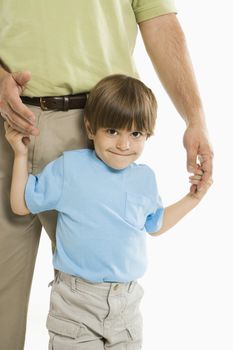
[145,169,164,233]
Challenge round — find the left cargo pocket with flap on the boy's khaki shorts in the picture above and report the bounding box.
[46,315,83,350]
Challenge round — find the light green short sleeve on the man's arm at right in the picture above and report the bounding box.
[132,0,177,23]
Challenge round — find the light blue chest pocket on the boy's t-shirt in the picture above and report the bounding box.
[125,192,150,230]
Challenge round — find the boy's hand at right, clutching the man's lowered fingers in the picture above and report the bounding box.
[189,165,213,200]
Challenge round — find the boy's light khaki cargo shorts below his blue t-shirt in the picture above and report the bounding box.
[47,272,143,350]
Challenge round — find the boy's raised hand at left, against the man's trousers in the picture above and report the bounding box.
[4,121,30,156]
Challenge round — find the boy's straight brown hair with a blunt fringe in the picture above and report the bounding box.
[84,74,157,137]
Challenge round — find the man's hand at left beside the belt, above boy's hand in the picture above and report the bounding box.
[0,70,39,136]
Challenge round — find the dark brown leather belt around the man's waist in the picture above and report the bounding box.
[21,93,88,111]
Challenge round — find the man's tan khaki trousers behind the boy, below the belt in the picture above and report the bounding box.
[0,106,87,350]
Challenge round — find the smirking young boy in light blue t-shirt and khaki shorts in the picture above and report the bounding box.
[5,75,211,350]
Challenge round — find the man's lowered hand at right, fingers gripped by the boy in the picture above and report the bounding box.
[183,123,213,193]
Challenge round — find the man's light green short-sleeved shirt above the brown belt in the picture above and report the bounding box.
[0,0,175,96]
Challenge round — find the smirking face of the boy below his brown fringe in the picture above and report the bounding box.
[86,124,147,170]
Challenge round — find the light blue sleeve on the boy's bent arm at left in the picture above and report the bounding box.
[25,156,64,214]
